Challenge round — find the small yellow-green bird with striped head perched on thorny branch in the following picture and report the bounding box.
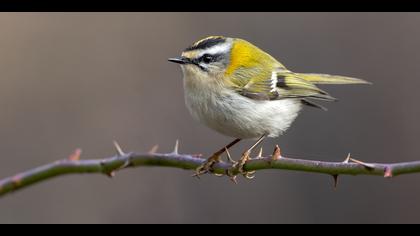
[168,36,369,177]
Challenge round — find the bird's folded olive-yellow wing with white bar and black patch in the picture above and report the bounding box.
[237,68,336,101]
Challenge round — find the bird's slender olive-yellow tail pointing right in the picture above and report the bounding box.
[295,73,372,84]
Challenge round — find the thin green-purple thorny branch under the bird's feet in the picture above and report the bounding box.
[0,141,420,196]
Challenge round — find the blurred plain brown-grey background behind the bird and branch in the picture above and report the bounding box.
[0,13,420,223]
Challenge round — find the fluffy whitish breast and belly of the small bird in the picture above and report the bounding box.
[184,68,302,139]
